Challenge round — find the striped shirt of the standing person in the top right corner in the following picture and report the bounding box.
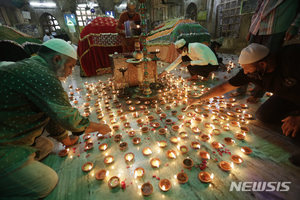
[249,0,300,35]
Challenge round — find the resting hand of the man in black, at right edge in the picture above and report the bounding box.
[281,116,300,137]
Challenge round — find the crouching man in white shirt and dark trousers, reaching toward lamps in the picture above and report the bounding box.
[159,39,219,80]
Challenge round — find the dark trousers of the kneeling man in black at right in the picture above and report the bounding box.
[256,95,300,141]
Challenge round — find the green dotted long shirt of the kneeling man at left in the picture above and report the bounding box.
[0,56,89,172]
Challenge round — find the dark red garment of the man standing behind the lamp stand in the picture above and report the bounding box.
[116,11,141,53]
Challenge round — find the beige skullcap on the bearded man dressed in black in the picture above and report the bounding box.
[239,43,270,64]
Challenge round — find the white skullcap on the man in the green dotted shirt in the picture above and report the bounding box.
[43,39,77,60]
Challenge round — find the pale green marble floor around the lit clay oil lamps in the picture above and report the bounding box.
[43,55,300,200]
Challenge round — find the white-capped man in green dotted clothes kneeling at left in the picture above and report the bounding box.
[0,39,110,199]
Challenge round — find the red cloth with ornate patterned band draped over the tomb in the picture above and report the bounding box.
[77,17,122,76]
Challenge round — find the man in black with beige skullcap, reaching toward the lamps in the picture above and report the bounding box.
[189,43,300,165]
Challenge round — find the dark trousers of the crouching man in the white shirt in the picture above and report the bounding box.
[182,56,219,78]
